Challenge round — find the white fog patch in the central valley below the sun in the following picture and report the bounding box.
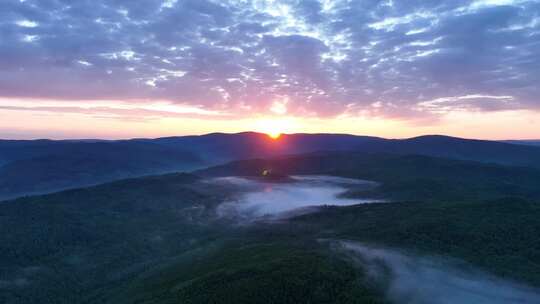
[215,176,380,219]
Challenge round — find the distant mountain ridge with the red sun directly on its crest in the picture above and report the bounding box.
[149,132,540,168]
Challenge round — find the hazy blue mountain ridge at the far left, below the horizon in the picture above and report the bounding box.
[0,140,201,199]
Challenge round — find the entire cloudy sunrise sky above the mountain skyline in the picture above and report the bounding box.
[0,0,540,139]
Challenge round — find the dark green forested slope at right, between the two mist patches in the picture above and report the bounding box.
[294,198,540,286]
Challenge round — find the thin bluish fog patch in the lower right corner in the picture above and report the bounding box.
[336,241,540,304]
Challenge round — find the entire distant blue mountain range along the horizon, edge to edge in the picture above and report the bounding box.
[0,132,540,199]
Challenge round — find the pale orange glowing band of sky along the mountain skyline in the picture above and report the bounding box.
[0,98,540,142]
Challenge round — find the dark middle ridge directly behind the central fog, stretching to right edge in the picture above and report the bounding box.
[198,152,540,201]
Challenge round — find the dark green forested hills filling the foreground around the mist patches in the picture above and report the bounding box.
[0,152,540,304]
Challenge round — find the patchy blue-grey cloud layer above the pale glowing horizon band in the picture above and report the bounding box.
[0,0,540,118]
